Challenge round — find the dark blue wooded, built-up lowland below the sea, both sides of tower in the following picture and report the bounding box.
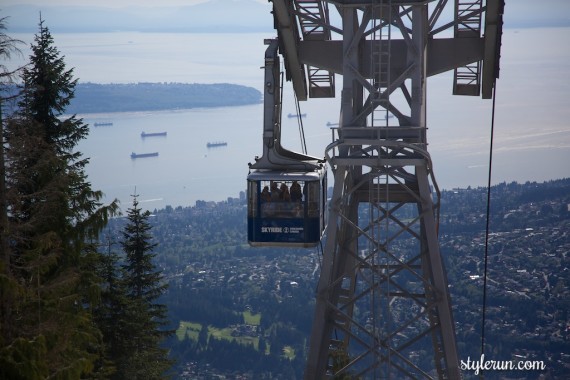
[100,179,570,379]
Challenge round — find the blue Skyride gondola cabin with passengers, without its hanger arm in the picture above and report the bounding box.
[247,167,327,247]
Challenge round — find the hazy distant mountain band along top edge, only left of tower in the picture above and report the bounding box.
[0,0,273,33]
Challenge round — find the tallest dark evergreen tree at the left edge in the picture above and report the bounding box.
[0,20,117,379]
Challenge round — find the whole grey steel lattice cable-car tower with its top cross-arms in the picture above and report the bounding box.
[266,0,503,380]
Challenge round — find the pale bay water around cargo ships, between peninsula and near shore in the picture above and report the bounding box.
[79,105,261,210]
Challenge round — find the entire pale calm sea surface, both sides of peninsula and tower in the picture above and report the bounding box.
[7,28,570,210]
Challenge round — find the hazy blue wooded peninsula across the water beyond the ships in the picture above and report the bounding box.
[66,83,261,114]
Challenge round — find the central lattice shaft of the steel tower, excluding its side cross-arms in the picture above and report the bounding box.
[305,4,460,380]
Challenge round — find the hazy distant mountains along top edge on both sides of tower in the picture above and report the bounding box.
[4,0,570,33]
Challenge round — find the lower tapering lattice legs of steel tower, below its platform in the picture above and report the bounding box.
[305,160,460,379]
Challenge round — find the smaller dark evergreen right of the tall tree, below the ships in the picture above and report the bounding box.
[117,195,173,379]
